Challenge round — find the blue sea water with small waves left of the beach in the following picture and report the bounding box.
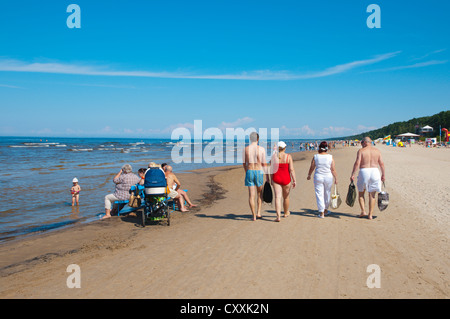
[0,137,314,242]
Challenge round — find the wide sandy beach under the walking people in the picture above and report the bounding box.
[0,145,450,299]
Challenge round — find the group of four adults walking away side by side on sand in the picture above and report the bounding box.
[243,132,385,222]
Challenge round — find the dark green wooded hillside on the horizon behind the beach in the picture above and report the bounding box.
[333,111,450,140]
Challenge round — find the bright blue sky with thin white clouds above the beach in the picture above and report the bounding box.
[0,0,450,138]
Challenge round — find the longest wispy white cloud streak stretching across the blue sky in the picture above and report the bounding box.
[0,52,400,81]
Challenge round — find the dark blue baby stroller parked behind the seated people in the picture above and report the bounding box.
[142,167,170,227]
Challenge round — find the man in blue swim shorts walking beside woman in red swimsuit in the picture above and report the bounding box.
[242,132,266,220]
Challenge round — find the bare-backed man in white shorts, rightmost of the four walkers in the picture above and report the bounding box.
[350,137,385,219]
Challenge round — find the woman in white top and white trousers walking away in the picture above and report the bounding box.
[307,141,337,218]
